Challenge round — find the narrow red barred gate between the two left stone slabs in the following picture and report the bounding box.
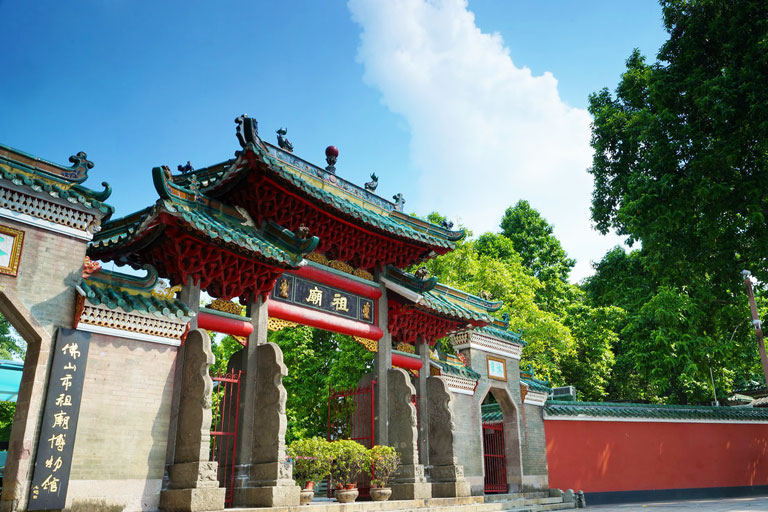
[211,370,240,507]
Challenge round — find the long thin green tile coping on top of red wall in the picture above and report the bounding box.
[544,400,768,421]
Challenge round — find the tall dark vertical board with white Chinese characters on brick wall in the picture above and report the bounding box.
[28,329,90,510]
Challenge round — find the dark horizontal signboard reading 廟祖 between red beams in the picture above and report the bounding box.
[270,273,376,324]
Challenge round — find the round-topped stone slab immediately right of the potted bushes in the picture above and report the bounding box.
[389,368,432,500]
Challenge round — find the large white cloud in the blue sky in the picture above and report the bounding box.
[349,0,620,280]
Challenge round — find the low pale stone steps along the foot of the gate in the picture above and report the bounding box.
[234,491,576,512]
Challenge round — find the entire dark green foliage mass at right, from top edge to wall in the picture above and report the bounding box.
[584,0,768,403]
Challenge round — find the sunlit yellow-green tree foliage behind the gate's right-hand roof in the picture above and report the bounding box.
[420,208,623,400]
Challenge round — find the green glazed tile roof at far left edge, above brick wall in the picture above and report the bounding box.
[0,146,115,217]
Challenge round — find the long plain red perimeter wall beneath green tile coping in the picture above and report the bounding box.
[544,420,768,492]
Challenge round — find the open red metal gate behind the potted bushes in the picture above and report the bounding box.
[328,380,376,498]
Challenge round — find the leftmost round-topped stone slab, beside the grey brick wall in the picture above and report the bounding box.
[160,329,226,512]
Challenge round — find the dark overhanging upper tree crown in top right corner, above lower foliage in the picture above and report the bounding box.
[589,0,768,290]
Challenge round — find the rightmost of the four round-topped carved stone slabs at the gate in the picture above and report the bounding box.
[427,376,471,498]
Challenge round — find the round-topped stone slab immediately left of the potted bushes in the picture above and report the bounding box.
[234,342,301,507]
